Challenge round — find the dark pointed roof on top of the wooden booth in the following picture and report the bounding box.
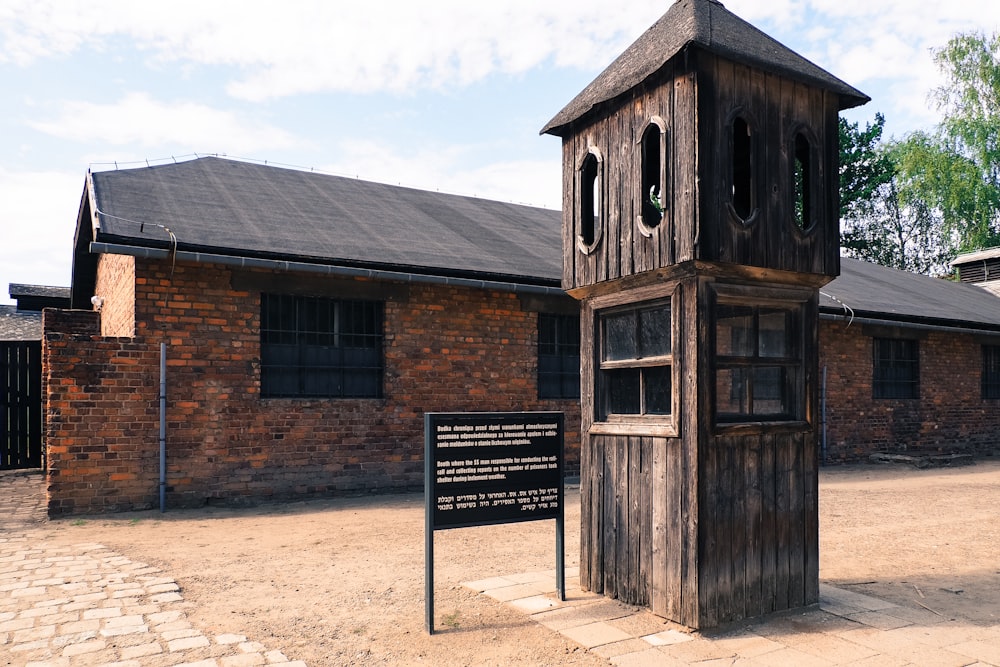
[542,0,869,134]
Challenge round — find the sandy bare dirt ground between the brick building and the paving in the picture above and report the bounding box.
[35,459,1000,666]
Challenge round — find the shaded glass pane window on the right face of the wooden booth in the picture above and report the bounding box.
[715,304,802,422]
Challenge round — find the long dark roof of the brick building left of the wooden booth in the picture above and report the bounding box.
[92,157,562,286]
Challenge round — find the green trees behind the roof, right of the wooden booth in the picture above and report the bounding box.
[840,33,1000,273]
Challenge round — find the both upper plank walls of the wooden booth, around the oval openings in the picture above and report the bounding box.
[563,53,840,289]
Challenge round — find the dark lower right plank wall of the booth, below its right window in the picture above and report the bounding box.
[699,433,819,627]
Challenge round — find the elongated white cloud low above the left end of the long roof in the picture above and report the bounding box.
[28,93,302,153]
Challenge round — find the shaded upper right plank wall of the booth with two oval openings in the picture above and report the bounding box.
[698,54,840,276]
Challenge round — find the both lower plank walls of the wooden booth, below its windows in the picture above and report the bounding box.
[580,433,819,627]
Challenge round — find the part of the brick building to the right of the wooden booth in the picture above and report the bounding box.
[819,258,1000,461]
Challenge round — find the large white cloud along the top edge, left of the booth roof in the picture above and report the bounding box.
[0,0,664,100]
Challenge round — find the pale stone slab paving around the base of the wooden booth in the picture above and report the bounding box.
[465,573,1000,667]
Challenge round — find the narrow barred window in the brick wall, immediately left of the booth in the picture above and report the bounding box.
[538,313,580,398]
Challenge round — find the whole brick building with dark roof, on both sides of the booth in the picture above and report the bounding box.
[42,158,1000,515]
